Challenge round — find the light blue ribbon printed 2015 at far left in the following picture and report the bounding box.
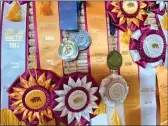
[0,1,27,108]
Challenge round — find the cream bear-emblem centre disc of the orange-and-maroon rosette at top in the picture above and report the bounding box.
[122,1,138,14]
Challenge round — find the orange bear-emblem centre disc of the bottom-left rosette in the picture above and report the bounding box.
[25,90,47,110]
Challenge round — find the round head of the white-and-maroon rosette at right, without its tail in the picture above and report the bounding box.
[130,25,166,68]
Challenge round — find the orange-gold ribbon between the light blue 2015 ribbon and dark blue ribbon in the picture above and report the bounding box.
[35,1,63,76]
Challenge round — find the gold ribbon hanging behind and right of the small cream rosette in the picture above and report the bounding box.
[119,31,141,125]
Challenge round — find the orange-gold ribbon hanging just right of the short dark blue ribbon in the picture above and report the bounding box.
[86,1,110,84]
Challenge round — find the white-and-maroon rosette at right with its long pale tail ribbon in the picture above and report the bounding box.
[130,12,167,125]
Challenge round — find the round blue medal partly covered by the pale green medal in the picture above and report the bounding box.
[72,30,91,50]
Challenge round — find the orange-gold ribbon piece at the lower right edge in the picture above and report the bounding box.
[156,66,168,125]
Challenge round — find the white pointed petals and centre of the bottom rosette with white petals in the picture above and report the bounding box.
[53,76,100,125]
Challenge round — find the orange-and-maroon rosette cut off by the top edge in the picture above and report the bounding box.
[106,1,147,32]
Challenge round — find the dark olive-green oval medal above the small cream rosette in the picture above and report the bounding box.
[107,51,122,70]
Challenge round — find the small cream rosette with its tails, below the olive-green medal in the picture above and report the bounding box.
[99,74,128,125]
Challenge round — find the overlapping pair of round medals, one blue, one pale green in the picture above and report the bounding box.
[59,30,91,61]
